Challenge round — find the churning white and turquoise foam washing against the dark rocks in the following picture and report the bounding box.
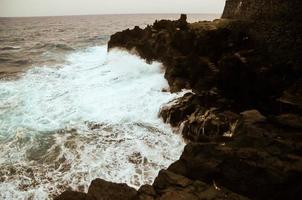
[0,46,184,199]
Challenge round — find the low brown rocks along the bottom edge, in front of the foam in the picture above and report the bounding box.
[56,170,248,200]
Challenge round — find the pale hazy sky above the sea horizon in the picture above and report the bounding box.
[0,0,225,17]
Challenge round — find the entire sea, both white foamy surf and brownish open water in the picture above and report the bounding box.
[0,14,219,200]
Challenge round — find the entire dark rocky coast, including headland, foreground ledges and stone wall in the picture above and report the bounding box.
[56,0,302,200]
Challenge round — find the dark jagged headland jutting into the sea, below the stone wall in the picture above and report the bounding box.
[108,14,302,112]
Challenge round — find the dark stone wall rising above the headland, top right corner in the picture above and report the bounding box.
[222,0,302,81]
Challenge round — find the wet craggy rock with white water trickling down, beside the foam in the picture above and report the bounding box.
[160,93,241,142]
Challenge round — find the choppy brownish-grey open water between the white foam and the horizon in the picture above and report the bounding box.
[0,14,219,75]
